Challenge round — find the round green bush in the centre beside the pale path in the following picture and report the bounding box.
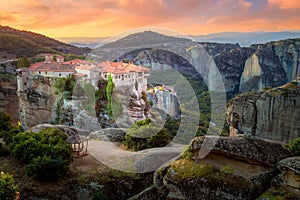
[123,119,170,151]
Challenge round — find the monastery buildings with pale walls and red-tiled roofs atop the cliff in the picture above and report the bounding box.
[17,54,150,92]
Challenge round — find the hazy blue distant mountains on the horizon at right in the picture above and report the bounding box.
[190,31,300,46]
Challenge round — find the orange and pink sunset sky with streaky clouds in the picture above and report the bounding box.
[0,0,300,38]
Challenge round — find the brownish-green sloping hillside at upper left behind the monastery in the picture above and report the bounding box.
[0,25,91,57]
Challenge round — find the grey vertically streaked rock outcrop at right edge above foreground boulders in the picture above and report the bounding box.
[227,79,300,143]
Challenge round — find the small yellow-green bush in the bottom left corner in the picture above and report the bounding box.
[0,172,18,200]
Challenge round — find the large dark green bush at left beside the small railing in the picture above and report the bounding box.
[10,128,72,180]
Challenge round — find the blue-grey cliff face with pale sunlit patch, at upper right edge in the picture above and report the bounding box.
[240,39,300,92]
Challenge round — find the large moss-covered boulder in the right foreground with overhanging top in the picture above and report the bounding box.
[150,137,292,199]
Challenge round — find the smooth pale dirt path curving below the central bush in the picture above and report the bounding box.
[85,140,183,173]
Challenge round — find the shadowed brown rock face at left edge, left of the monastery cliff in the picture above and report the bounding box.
[0,77,19,123]
